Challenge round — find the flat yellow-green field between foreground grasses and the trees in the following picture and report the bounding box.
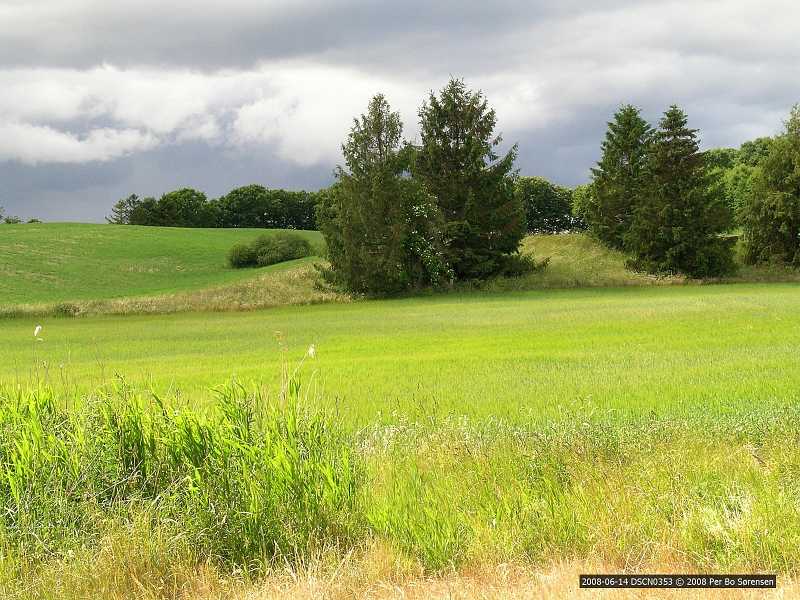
[0,283,800,424]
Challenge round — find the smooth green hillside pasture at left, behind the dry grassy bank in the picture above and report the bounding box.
[0,223,322,306]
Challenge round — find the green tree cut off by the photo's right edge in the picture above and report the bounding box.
[742,104,800,267]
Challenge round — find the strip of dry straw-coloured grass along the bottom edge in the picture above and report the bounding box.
[16,549,800,600]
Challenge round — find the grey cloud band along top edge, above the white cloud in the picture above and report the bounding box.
[0,0,612,70]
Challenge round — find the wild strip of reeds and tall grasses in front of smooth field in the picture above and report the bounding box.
[0,379,800,598]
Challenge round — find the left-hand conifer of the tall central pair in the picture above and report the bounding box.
[317,94,441,293]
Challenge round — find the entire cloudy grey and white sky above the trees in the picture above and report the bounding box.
[0,0,800,222]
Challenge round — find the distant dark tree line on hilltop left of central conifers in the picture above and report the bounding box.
[106,184,318,229]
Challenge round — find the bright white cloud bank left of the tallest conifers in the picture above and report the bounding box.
[0,63,420,166]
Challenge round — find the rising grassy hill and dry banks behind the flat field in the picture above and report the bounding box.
[0,223,800,317]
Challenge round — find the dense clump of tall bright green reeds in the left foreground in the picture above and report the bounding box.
[0,379,358,571]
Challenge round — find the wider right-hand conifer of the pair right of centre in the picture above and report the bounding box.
[623,105,734,277]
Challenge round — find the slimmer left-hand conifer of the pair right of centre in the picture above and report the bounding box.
[581,104,653,250]
